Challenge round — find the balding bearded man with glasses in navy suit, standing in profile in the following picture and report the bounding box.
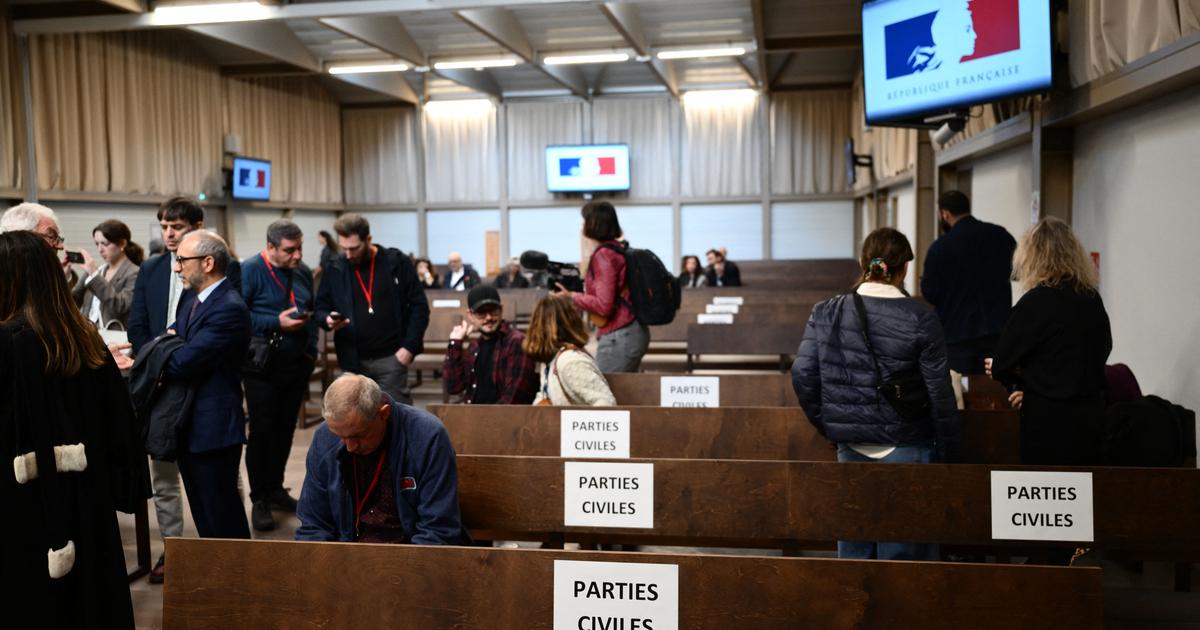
[164,230,250,539]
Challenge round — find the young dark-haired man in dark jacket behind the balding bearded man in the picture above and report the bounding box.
[127,197,241,584]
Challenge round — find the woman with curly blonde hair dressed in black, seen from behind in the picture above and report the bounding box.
[991,217,1112,466]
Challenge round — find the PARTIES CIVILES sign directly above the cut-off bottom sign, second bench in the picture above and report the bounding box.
[563,462,654,529]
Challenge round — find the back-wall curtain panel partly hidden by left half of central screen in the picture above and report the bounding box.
[505,101,583,202]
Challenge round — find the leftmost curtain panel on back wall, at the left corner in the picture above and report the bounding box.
[342,107,418,205]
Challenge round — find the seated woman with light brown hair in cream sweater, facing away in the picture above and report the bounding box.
[521,295,617,407]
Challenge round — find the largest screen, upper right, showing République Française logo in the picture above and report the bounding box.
[863,0,1052,126]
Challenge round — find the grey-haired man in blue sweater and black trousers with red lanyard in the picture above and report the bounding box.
[241,218,317,532]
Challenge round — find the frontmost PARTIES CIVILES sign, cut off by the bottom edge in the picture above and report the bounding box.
[554,560,679,630]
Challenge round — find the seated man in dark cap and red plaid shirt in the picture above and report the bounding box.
[442,284,538,404]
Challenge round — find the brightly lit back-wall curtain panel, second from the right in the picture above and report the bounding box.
[679,90,762,198]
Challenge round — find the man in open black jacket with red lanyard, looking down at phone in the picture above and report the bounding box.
[314,214,430,404]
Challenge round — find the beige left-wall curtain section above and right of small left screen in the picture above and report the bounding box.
[224,77,342,203]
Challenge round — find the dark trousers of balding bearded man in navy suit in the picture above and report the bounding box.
[179,444,250,539]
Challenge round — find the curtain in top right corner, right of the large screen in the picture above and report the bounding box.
[1069,0,1200,86]
